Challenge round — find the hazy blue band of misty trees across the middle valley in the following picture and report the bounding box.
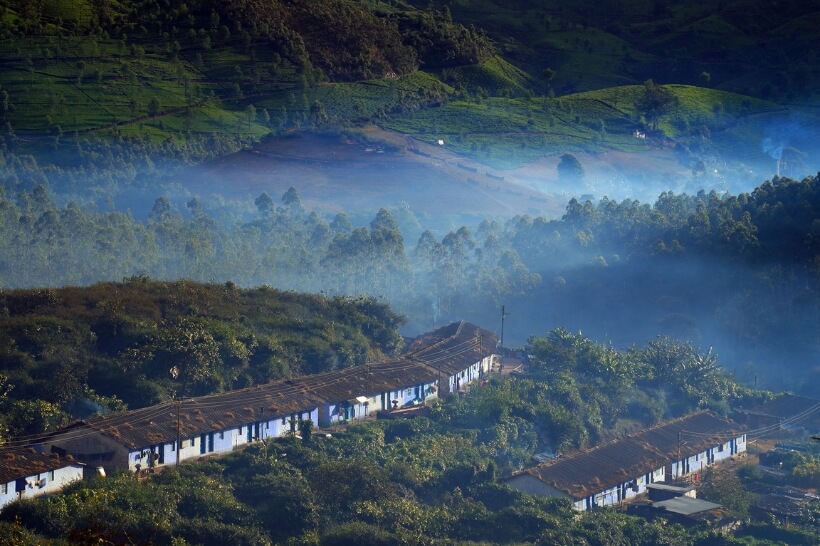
[0,172,820,389]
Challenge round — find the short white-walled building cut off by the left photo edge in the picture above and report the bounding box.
[0,446,83,508]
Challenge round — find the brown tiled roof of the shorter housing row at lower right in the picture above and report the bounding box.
[526,411,742,500]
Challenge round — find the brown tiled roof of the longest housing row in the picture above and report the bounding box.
[54,322,496,449]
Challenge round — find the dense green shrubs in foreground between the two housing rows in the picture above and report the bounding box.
[0,330,792,546]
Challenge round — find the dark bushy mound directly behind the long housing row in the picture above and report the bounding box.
[0,277,403,435]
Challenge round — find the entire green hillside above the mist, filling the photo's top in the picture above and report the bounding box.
[0,0,818,191]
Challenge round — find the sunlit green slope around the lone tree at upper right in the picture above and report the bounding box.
[385,85,782,167]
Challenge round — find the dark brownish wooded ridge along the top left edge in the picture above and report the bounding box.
[0,0,494,81]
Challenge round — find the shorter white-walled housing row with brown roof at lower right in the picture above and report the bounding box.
[504,411,746,510]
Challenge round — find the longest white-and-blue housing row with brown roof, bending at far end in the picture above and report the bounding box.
[35,322,497,471]
